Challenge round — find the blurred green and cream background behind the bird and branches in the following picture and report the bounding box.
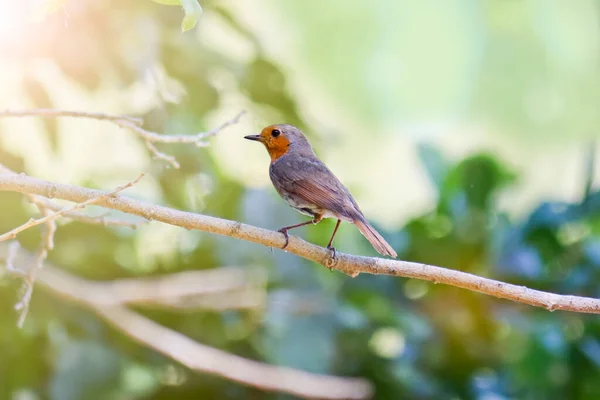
[0,0,600,400]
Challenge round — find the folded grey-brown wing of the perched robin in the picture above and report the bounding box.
[270,157,360,219]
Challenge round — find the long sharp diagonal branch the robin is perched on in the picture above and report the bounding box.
[0,175,600,314]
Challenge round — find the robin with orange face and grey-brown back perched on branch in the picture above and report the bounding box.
[245,124,396,258]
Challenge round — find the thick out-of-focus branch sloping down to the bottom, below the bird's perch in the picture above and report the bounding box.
[0,243,373,399]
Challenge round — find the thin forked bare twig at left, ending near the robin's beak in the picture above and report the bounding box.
[0,109,245,168]
